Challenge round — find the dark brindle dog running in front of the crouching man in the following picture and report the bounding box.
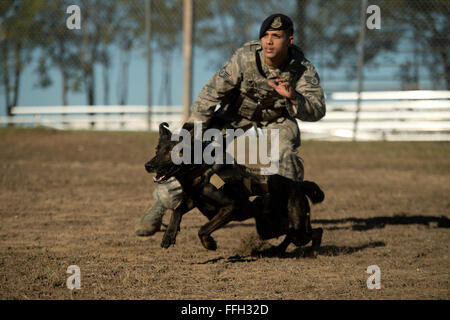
[145,123,324,254]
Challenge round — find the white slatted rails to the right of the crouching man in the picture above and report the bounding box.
[299,90,450,141]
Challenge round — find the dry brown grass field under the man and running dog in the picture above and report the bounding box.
[0,128,450,300]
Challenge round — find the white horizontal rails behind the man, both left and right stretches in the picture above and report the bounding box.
[0,91,450,141]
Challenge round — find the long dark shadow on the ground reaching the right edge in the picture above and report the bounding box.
[311,214,450,231]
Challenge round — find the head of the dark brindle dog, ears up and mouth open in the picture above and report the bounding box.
[145,122,182,183]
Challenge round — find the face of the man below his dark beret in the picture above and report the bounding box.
[261,30,294,60]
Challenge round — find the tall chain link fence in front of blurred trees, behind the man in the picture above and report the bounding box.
[0,0,450,115]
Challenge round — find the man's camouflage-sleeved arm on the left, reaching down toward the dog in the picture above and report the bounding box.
[188,48,243,122]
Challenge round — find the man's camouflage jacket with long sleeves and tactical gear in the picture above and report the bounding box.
[190,41,325,121]
